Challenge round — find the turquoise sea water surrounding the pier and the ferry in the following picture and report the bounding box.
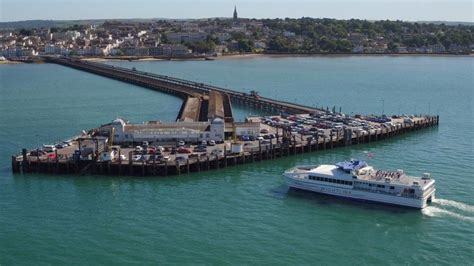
[0,56,474,265]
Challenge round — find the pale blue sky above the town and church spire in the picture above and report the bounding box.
[0,0,474,22]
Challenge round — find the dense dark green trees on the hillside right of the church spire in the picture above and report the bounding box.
[263,18,474,52]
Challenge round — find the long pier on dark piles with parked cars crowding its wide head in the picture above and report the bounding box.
[11,58,439,176]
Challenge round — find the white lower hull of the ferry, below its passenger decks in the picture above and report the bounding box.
[284,175,435,209]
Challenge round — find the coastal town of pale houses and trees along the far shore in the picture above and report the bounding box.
[0,7,474,61]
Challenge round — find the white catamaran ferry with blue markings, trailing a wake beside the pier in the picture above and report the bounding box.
[283,160,436,209]
